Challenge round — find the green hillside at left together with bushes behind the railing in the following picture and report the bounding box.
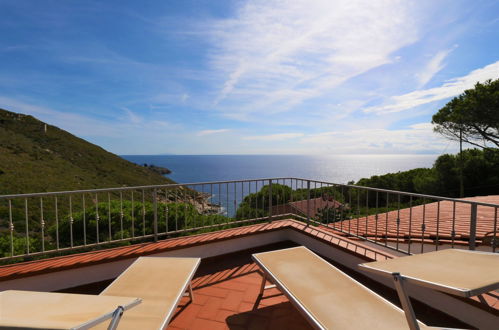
[0,109,221,257]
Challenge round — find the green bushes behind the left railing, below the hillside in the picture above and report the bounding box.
[0,200,230,257]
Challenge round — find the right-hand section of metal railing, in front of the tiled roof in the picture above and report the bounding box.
[298,179,499,254]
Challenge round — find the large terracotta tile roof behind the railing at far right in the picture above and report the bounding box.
[330,196,499,241]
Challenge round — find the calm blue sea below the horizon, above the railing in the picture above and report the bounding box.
[121,155,438,183]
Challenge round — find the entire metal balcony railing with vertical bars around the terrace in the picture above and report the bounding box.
[0,178,499,262]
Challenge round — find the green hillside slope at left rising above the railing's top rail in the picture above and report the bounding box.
[0,109,173,194]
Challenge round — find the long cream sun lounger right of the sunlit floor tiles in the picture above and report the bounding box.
[253,247,427,330]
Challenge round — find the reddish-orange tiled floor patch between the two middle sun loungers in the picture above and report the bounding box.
[168,241,311,330]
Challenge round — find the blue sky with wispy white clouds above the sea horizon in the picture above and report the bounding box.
[0,0,499,154]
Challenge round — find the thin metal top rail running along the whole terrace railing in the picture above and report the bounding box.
[0,177,499,208]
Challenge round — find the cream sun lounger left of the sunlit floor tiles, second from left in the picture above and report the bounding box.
[96,257,201,330]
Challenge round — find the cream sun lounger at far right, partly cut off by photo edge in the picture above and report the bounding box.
[359,249,499,329]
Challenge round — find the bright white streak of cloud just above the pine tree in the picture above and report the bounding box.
[364,61,499,114]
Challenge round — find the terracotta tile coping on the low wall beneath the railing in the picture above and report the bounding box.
[0,220,393,281]
